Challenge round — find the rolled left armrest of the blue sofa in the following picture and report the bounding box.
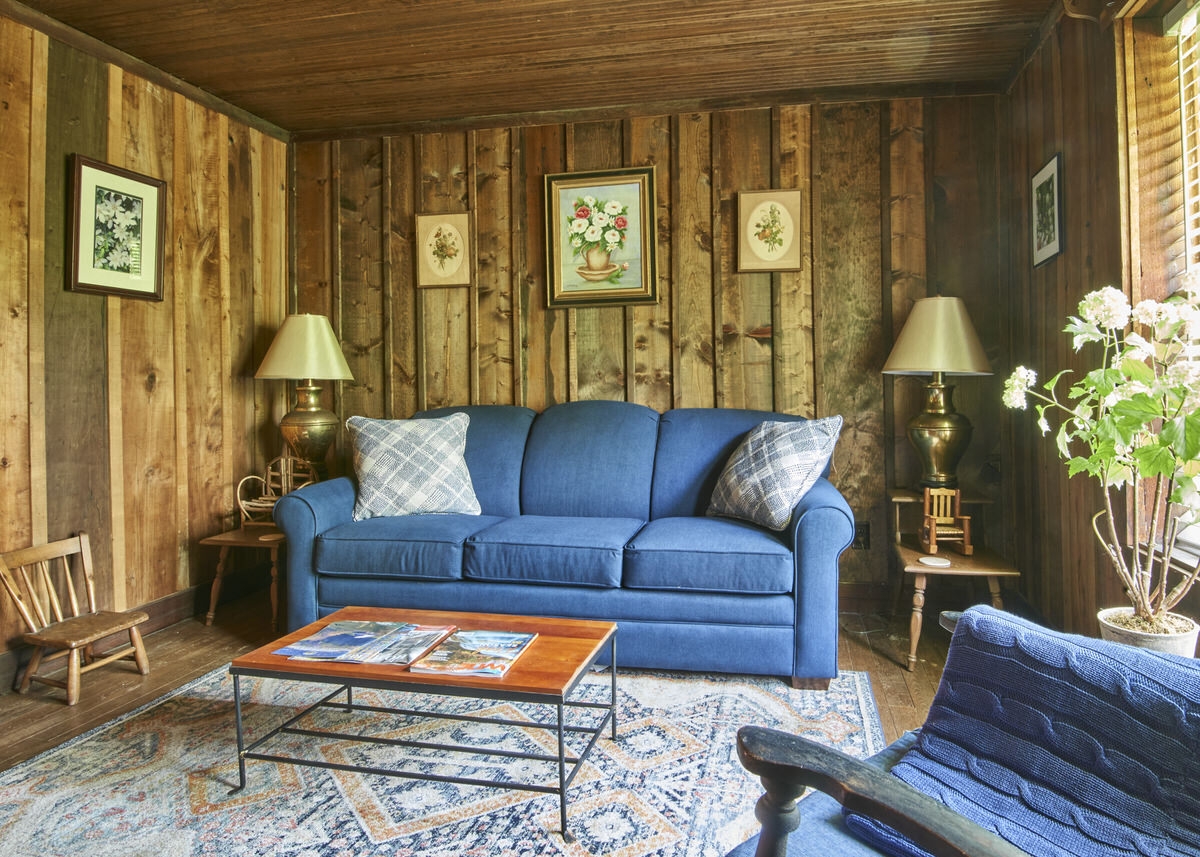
[274,477,355,630]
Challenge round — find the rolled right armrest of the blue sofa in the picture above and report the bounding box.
[788,477,854,679]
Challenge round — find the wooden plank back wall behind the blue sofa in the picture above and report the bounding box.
[293,97,1001,597]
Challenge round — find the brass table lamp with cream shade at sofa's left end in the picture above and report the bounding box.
[254,313,354,474]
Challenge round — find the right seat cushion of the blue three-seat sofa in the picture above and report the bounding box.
[623,517,796,595]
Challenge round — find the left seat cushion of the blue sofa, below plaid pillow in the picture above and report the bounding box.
[313,514,504,580]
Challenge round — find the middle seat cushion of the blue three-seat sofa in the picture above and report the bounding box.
[463,515,644,588]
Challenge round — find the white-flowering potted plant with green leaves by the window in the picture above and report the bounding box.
[1004,281,1200,655]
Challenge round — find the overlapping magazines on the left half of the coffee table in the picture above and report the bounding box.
[275,621,455,666]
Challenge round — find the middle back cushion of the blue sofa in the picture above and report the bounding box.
[521,401,659,521]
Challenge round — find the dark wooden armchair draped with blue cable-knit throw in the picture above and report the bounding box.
[731,607,1200,857]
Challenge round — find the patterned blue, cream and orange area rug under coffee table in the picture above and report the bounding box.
[0,669,883,857]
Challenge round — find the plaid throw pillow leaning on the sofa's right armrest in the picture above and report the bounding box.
[708,416,841,529]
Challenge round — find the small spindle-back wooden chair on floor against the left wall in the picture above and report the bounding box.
[0,533,150,706]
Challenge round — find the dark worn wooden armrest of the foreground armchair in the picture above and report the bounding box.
[738,726,1025,857]
